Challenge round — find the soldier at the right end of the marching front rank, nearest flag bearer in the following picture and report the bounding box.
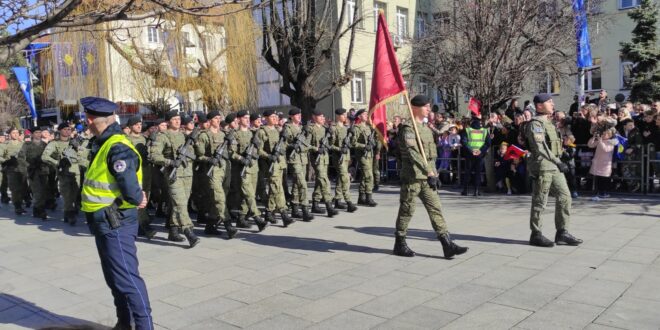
[354,109,378,207]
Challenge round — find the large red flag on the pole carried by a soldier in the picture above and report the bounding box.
[369,11,406,146]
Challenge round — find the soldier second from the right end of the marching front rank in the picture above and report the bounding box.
[330,108,357,212]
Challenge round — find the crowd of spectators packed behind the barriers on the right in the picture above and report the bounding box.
[388,90,660,200]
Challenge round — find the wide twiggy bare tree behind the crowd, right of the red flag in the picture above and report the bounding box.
[410,0,600,111]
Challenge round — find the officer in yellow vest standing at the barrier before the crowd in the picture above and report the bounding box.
[461,113,491,197]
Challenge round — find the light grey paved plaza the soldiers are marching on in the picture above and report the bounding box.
[0,187,660,329]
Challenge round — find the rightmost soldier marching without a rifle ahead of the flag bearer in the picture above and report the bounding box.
[525,93,582,247]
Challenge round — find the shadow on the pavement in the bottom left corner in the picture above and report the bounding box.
[0,293,110,330]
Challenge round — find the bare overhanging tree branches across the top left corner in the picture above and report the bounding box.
[0,0,262,62]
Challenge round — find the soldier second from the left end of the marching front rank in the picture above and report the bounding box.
[195,111,237,239]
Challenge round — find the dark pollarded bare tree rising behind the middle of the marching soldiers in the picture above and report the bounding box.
[261,0,361,117]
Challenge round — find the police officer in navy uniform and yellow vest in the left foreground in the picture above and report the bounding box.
[80,97,153,330]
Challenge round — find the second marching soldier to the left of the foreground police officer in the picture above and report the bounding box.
[18,128,48,220]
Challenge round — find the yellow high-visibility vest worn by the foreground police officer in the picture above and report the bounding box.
[80,134,142,212]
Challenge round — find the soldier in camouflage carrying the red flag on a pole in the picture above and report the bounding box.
[394,95,468,259]
